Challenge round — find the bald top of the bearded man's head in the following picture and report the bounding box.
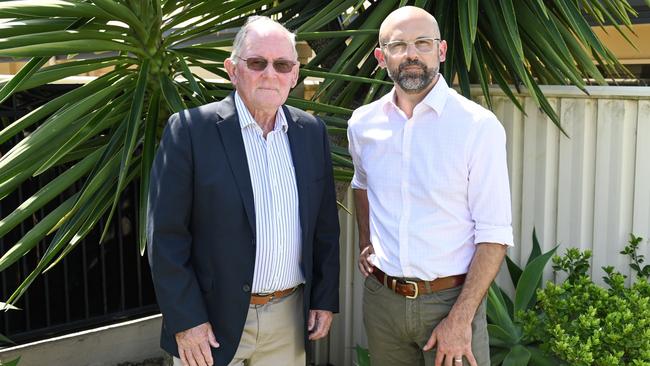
[379,6,440,44]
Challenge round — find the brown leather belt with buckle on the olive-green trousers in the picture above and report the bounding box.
[372,267,465,299]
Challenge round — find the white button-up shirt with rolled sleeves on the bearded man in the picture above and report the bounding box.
[348,75,513,280]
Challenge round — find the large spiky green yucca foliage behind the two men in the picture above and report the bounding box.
[0,0,633,303]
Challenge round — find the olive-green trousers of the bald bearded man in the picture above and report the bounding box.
[363,275,490,366]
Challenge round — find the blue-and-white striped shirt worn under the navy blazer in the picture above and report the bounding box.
[235,92,305,293]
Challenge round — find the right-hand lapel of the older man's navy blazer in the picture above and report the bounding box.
[282,106,309,244]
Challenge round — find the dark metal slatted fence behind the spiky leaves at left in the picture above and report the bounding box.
[0,85,158,343]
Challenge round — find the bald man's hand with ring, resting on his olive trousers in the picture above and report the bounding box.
[423,317,477,366]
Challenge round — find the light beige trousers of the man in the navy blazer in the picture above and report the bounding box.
[174,286,306,366]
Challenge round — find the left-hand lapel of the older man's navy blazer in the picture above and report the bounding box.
[217,93,256,233]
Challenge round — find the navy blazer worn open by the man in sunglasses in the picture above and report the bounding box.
[147,94,339,365]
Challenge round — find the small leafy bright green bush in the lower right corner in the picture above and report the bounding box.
[519,236,650,366]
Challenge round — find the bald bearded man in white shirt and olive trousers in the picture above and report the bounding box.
[348,7,513,366]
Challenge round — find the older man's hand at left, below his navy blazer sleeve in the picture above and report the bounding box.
[176,323,219,366]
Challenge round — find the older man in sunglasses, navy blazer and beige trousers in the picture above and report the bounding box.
[147,17,339,366]
